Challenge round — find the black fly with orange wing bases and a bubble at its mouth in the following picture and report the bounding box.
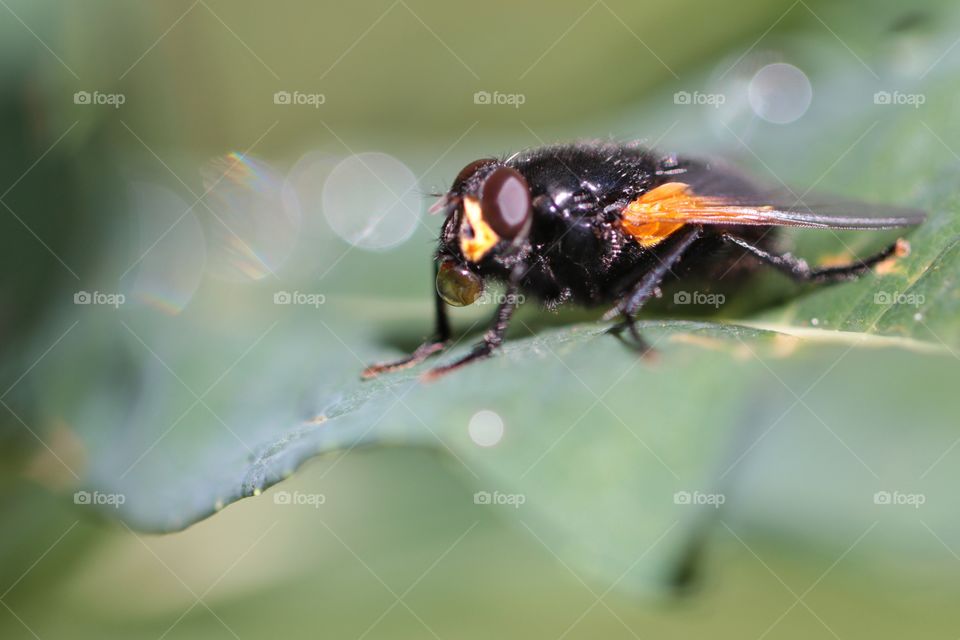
[363,142,924,379]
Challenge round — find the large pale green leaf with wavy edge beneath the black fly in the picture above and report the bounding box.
[16,0,960,590]
